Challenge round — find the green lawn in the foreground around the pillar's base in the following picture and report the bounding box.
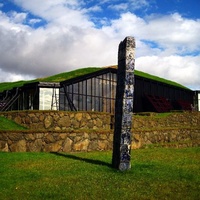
[0,147,200,200]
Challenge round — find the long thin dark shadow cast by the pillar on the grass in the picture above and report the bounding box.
[50,152,112,168]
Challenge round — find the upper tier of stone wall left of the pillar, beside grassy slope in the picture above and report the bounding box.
[0,111,111,131]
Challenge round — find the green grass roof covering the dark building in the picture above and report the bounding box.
[0,66,189,92]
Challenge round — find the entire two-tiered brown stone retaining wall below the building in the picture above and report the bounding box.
[0,111,200,152]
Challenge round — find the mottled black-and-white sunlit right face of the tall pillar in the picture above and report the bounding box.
[119,37,135,171]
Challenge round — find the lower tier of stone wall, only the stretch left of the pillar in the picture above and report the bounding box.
[0,130,113,152]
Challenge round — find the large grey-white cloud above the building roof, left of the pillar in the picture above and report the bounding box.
[0,9,117,77]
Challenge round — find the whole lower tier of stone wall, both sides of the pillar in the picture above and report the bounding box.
[0,128,200,152]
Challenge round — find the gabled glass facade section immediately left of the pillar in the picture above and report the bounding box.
[60,72,117,113]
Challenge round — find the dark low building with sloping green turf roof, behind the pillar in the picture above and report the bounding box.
[0,66,198,113]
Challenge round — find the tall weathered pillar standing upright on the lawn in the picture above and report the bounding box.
[112,37,135,171]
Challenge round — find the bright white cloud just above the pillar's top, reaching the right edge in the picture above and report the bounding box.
[103,12,200,54]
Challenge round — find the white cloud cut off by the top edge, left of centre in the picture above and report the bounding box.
[12,0,93,28]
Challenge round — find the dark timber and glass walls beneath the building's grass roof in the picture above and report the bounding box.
[0,68,196,113]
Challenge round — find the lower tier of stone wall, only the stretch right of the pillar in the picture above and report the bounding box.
[132,127,200,149]
